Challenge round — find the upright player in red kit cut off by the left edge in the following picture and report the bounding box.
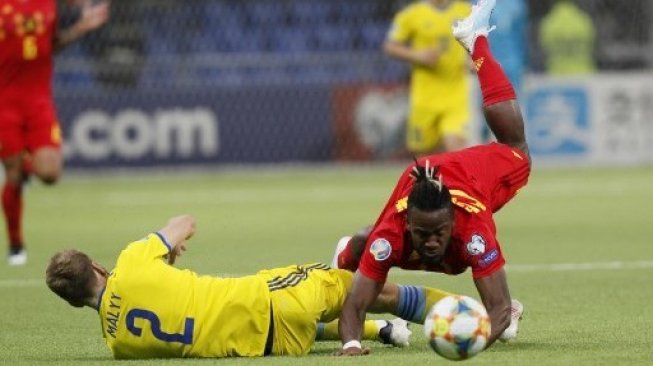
[0,0,109,265]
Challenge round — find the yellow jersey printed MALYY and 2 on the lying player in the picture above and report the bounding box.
[98,233,270,359]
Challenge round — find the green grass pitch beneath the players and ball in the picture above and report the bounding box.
[0,166,653,366]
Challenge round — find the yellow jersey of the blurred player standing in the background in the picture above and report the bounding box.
[388,0,471,109]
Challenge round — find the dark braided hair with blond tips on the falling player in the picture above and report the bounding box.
[408,159,453,212]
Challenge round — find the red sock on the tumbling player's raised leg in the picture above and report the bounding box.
[472,36,516,107]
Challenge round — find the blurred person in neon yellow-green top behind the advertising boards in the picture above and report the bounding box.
[539,0,596,75]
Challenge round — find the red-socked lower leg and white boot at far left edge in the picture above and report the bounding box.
[2,153,27,266]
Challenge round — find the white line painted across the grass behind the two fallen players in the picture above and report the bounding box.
[0,261,653,288]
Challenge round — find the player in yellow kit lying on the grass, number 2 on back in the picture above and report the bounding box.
[46,215,456,359]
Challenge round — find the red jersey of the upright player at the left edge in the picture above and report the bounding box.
[0,0,57,98]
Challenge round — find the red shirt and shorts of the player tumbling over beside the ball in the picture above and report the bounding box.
[358,143,530,282]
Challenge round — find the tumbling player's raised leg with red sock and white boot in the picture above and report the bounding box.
[453,0,528,156]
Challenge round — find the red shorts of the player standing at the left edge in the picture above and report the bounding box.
[0,96,61,158]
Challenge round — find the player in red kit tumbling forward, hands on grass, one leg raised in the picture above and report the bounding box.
[334,0,530,355]
